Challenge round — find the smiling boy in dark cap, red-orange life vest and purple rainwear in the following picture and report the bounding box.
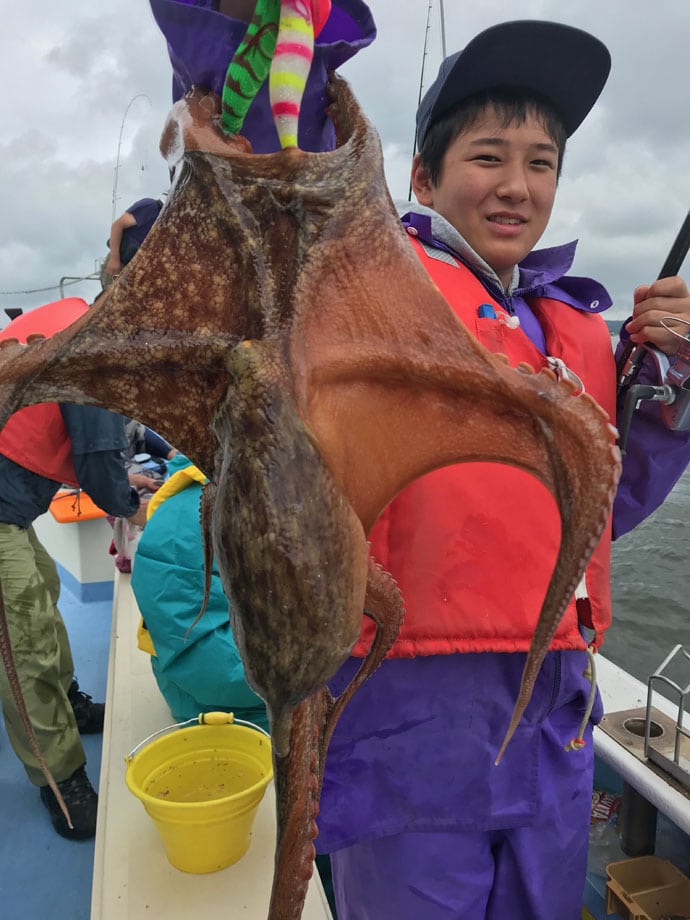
[316,22,690,920]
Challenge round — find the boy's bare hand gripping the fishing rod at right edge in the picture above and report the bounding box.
[625,275,690,355]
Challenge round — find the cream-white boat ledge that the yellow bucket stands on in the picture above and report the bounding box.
[91,573,331,920]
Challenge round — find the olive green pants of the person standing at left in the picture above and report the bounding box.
[0,523,86,786]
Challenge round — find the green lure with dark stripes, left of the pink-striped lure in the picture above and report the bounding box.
[221,0,280,134]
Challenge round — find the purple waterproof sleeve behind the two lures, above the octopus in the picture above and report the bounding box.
[145,0,376,153]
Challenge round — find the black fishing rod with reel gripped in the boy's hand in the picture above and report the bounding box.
[616,211,690,455]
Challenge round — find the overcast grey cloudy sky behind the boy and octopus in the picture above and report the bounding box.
[0,0,690,326]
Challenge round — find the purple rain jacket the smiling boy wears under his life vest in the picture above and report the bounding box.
[316,204,690,856]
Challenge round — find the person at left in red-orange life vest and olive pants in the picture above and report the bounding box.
[0,298,147,839]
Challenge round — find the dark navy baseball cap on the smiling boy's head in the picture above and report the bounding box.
[417,19,611,147]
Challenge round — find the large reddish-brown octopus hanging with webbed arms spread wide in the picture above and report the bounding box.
[0,78,620,920]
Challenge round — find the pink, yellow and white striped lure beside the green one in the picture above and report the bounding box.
[268,0,331,150]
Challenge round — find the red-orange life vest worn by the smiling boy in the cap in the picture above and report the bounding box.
[353,241,615,657]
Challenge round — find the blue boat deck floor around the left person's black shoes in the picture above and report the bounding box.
[0,585,112,920]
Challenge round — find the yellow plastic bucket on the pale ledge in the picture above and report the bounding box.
[125,713,273,874]
